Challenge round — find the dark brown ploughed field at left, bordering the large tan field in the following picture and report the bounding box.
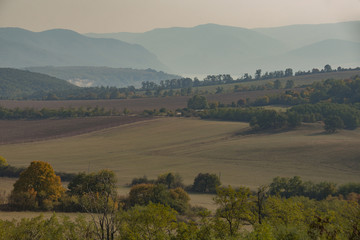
[0,116,148,145]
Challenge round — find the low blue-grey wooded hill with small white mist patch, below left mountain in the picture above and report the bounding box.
[27,67,180,87]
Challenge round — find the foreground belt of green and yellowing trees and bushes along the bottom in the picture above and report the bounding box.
[0,158,360,240]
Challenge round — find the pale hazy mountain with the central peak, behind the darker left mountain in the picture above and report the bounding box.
[88,24,285,73]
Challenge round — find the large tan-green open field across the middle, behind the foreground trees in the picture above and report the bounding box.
[0,118,360,189]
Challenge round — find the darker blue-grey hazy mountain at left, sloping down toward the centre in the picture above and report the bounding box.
[0,28,166,70]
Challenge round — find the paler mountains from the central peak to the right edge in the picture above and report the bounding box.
[87,21,360,74]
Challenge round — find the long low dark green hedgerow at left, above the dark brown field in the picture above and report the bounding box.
[0,106,119,120]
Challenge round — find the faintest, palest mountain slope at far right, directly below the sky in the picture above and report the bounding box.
[253,21,360,48]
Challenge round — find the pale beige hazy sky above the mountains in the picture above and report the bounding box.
[0,0,360,33]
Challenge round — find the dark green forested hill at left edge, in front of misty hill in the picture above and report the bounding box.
[0,68,78,99]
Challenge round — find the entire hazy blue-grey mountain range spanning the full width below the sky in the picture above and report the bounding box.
[0,21,360,77]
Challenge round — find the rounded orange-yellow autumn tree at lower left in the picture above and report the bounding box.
[10,161,65,210]
